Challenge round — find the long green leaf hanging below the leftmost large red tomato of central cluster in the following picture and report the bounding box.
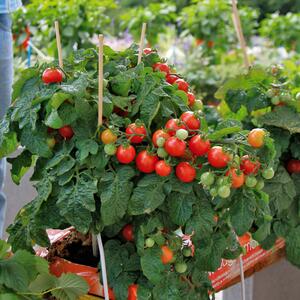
[99,166,135,225]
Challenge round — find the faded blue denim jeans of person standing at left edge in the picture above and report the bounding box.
[0,14,13,238]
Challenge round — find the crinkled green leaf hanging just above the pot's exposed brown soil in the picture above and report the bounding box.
[57,173,97,233]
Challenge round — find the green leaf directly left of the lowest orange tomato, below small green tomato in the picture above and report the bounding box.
[141,248,165,284]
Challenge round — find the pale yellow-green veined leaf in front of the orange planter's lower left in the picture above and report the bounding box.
[51,273,88,300]
